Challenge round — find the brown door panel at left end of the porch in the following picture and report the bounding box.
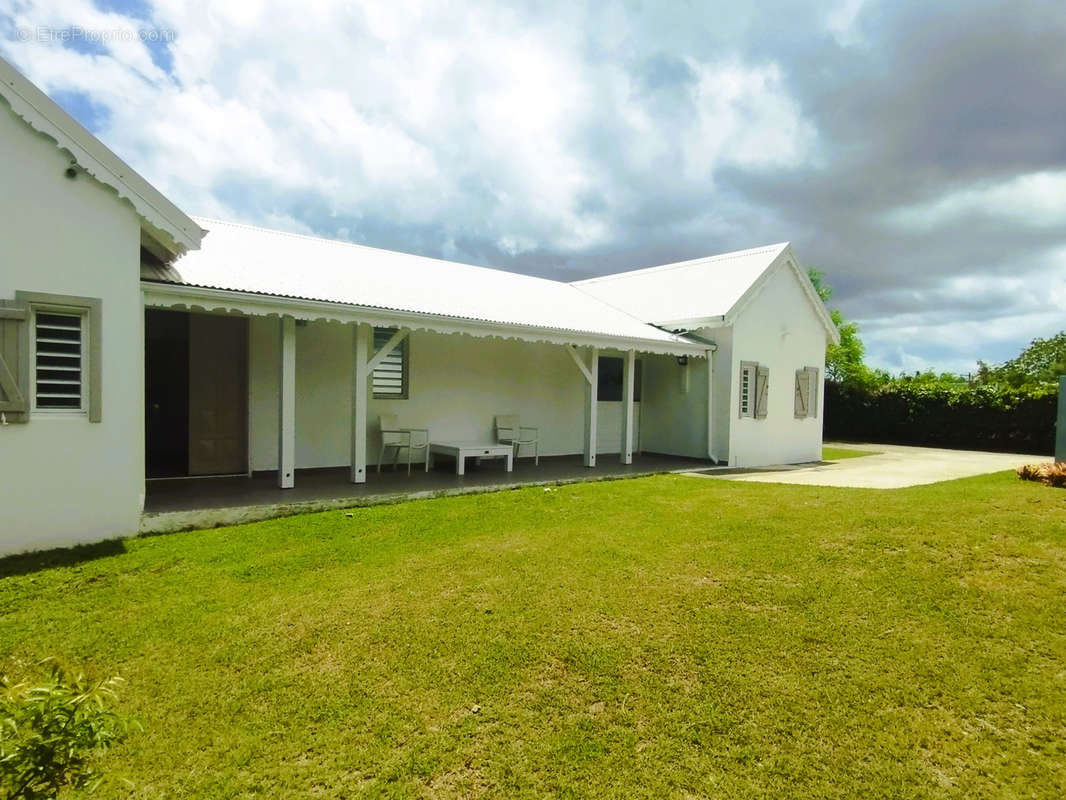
[189,314,248,475]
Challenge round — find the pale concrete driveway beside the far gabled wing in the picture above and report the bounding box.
[688,442,1052,489]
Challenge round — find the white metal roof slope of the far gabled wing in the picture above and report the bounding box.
[572,242,789,323]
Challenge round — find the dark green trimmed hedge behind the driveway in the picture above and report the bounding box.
[825,381,1059,455]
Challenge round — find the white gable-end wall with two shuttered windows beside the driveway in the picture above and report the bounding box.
[728,268,826,466]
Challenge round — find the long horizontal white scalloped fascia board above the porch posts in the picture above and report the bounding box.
[141,281,707,358]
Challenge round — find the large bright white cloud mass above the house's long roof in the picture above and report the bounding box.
[0,0,813,256]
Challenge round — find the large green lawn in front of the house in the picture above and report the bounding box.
[0,474,1066,800]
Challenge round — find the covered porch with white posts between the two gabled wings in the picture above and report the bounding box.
[135,270,714,532]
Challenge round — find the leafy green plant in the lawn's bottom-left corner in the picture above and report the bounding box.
[0,659,131,800]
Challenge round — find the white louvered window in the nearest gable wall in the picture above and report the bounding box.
[33,311,85,411]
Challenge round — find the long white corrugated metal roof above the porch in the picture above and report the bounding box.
[159,218,691,345]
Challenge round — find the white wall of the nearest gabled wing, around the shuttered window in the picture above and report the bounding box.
[0,103,144,553]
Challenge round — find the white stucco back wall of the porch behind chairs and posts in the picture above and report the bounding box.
[249,317,640,469]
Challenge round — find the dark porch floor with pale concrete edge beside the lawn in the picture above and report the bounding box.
[141,453,713,533]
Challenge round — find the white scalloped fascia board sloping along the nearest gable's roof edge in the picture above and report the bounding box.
[0,58,204,254]
